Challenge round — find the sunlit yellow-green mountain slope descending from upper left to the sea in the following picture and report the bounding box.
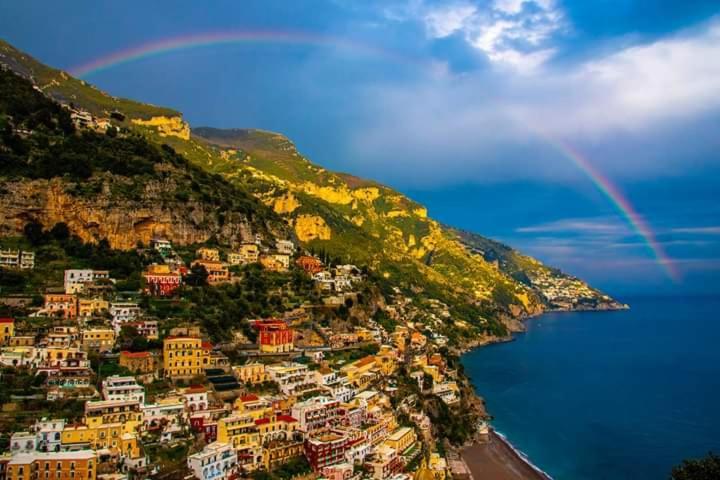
[0,40,618,338]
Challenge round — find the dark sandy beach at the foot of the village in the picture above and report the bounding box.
[461,431,549,480]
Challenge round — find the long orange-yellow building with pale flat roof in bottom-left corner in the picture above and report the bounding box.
[7,450,97,480]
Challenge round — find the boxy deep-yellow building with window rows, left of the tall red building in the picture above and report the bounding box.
[163,336,212,378]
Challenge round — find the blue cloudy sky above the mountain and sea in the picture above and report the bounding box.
[0,0,720,296]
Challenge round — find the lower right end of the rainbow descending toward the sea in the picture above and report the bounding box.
[542,139,680,282]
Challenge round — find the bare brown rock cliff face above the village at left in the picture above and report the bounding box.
[0,179,272,249]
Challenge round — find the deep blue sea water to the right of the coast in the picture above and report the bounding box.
[463,297,720,480]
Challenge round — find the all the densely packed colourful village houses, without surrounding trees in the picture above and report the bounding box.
[0,238,472,480]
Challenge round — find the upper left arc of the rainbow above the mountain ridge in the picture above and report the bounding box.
[69,30,420,78]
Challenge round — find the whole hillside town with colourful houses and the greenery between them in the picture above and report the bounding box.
[0,227,487,480]
